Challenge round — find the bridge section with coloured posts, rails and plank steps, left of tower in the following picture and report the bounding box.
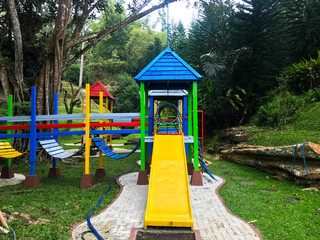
[0,82,144,188]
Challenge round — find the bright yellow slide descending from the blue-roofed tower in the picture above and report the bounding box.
[144,134,193,230]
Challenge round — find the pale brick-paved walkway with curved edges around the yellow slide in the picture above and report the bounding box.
[72,173,260,240]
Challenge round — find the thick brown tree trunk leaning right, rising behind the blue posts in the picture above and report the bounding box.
[35,0,71,115]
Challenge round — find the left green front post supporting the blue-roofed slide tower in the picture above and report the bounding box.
[140,82,146,171]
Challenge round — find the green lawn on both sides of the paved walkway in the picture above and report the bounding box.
[0,151,320,240]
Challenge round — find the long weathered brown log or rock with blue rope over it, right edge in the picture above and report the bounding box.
[221,142,320,187]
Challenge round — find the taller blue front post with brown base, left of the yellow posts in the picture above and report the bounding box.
[29,87,37,175]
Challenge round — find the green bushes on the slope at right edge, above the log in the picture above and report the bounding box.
[253,51,320,128]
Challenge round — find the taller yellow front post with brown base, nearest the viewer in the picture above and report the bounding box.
[84,84,91,174]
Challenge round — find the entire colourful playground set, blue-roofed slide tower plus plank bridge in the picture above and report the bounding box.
[0,48,208,229]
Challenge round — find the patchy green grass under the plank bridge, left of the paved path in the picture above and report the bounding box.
[0,154,139,240]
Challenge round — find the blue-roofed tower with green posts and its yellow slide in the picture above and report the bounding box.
[135,47,202,229]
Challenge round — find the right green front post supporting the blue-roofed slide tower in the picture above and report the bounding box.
[192,81,199,170]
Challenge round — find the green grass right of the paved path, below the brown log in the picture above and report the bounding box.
[208,156,320,240]
